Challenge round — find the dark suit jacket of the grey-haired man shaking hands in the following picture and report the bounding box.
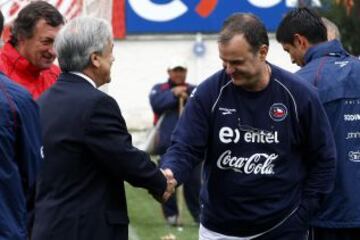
[32,73,166,240]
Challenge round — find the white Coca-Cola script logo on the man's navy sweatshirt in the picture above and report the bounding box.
[217,150,279,175]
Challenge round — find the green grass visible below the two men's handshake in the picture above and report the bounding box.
[126,184,198,240]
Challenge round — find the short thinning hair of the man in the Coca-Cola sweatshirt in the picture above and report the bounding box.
[218,13,269,53]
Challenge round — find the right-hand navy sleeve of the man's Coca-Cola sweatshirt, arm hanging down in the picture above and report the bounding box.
[300,90,336,217]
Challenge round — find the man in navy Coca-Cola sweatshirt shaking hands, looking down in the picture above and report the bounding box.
[161,13,335,240]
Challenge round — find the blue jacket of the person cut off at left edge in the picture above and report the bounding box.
[0,73,42,240]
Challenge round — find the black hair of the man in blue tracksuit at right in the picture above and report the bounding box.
[276,7,327,44]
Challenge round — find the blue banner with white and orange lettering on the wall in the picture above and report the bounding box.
[125,0,297,34]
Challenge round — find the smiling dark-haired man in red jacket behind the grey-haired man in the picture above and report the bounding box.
[0,1,64,99]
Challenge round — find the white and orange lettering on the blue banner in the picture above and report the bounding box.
[129,0,297,22]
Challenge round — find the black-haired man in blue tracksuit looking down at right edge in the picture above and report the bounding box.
[276,8,360,240]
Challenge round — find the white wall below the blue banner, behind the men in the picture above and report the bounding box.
[107,34,297,129]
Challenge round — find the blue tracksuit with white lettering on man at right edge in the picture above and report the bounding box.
[296,40,360,240]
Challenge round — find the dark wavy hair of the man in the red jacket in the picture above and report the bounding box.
[10,1,64,46]
